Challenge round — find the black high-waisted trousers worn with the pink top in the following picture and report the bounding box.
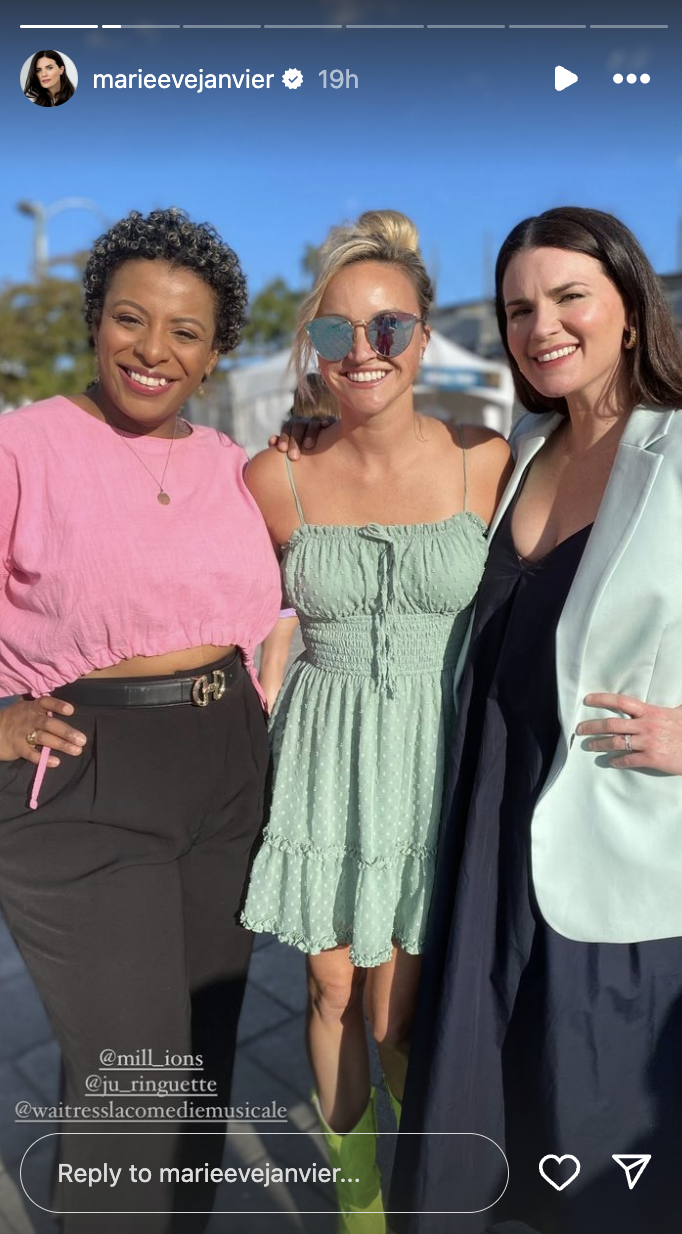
[0,670,268,1234]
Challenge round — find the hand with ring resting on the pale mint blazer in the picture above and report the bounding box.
[576,694,682,775]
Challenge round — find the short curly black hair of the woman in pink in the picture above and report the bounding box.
[83,207,248,353]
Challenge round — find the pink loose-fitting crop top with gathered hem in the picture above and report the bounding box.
[0,397,281,697]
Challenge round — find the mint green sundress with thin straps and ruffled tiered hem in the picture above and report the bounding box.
[242,454,487,967]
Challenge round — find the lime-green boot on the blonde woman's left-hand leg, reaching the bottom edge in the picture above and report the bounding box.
[312,1088,386,1234]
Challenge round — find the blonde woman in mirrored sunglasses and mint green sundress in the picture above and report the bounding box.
[243,211,509,1234]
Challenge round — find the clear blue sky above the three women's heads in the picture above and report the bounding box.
[0,0,682,302]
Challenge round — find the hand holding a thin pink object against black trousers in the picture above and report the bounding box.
[0,695,88,768]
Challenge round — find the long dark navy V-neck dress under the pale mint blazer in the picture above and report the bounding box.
[390,491,682,1234]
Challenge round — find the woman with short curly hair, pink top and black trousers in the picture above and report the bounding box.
[0,210,280,1234]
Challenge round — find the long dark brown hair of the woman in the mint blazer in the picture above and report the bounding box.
[495,206,682,415]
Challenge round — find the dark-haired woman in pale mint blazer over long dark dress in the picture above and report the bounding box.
[391,207,682,1234]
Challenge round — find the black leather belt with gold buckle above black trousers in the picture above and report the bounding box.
[51,652,243,707]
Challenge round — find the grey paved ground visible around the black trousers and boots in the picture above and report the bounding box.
[0,918,392,1234]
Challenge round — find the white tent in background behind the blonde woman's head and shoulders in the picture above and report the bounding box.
[218,331,513,455]
